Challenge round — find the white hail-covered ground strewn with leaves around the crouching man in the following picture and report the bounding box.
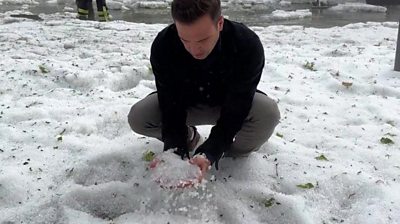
[0,11,400,224]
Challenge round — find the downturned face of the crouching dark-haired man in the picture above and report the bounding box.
[175,14,224,60]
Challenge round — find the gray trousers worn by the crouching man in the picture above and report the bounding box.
[128,92,280,156]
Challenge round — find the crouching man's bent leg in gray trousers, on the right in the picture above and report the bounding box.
[225,92,280,157]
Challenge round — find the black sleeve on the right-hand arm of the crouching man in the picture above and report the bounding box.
[210,34,265,148]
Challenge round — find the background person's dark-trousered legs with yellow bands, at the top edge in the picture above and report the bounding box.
[76,0,111,22]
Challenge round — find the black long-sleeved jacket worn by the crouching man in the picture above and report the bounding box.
[150,19,265,152]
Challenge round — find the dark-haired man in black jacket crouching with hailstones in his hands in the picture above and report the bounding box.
[128,0,280,178]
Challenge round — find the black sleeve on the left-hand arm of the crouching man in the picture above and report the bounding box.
[150,34,188,150]
